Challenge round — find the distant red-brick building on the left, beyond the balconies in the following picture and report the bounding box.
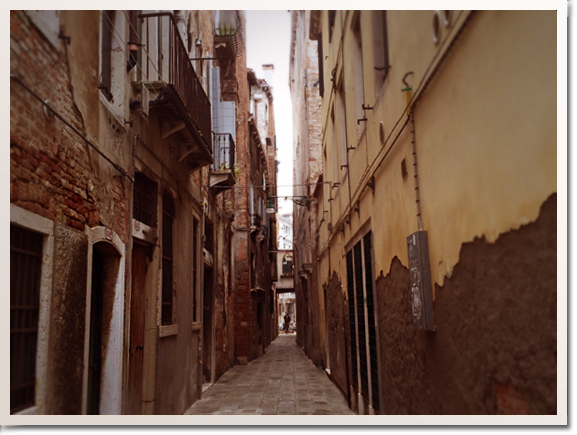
[232,66,278,364]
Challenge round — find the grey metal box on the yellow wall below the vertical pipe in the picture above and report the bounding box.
[407,231,435,331]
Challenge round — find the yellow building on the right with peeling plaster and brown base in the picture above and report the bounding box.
[304,10,557,414]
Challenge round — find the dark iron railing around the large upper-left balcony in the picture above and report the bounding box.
[139,12,212,164]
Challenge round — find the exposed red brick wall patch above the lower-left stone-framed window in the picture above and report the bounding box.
[10,11,130,242]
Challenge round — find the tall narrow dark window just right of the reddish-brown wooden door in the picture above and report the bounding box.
[161,192,176,325]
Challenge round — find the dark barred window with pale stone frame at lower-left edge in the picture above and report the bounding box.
[9,204,54,415]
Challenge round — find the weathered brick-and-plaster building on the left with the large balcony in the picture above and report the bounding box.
[10,6,248,414]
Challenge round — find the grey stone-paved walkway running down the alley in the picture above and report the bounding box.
[185,334,354,415]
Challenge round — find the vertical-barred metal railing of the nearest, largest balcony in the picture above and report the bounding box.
[139,12,212,147]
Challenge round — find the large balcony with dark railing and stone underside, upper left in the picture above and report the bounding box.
[134,12,213,170]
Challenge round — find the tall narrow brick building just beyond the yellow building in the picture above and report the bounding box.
[289,11,324,365]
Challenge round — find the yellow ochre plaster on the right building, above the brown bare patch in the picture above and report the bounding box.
[319,11,557,292]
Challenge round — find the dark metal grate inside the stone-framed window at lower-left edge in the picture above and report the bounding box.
[10,225,43,413]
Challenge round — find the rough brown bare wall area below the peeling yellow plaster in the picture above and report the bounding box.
[377,195,557,415]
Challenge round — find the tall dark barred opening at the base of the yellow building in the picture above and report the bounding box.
[346,231,380,412]
